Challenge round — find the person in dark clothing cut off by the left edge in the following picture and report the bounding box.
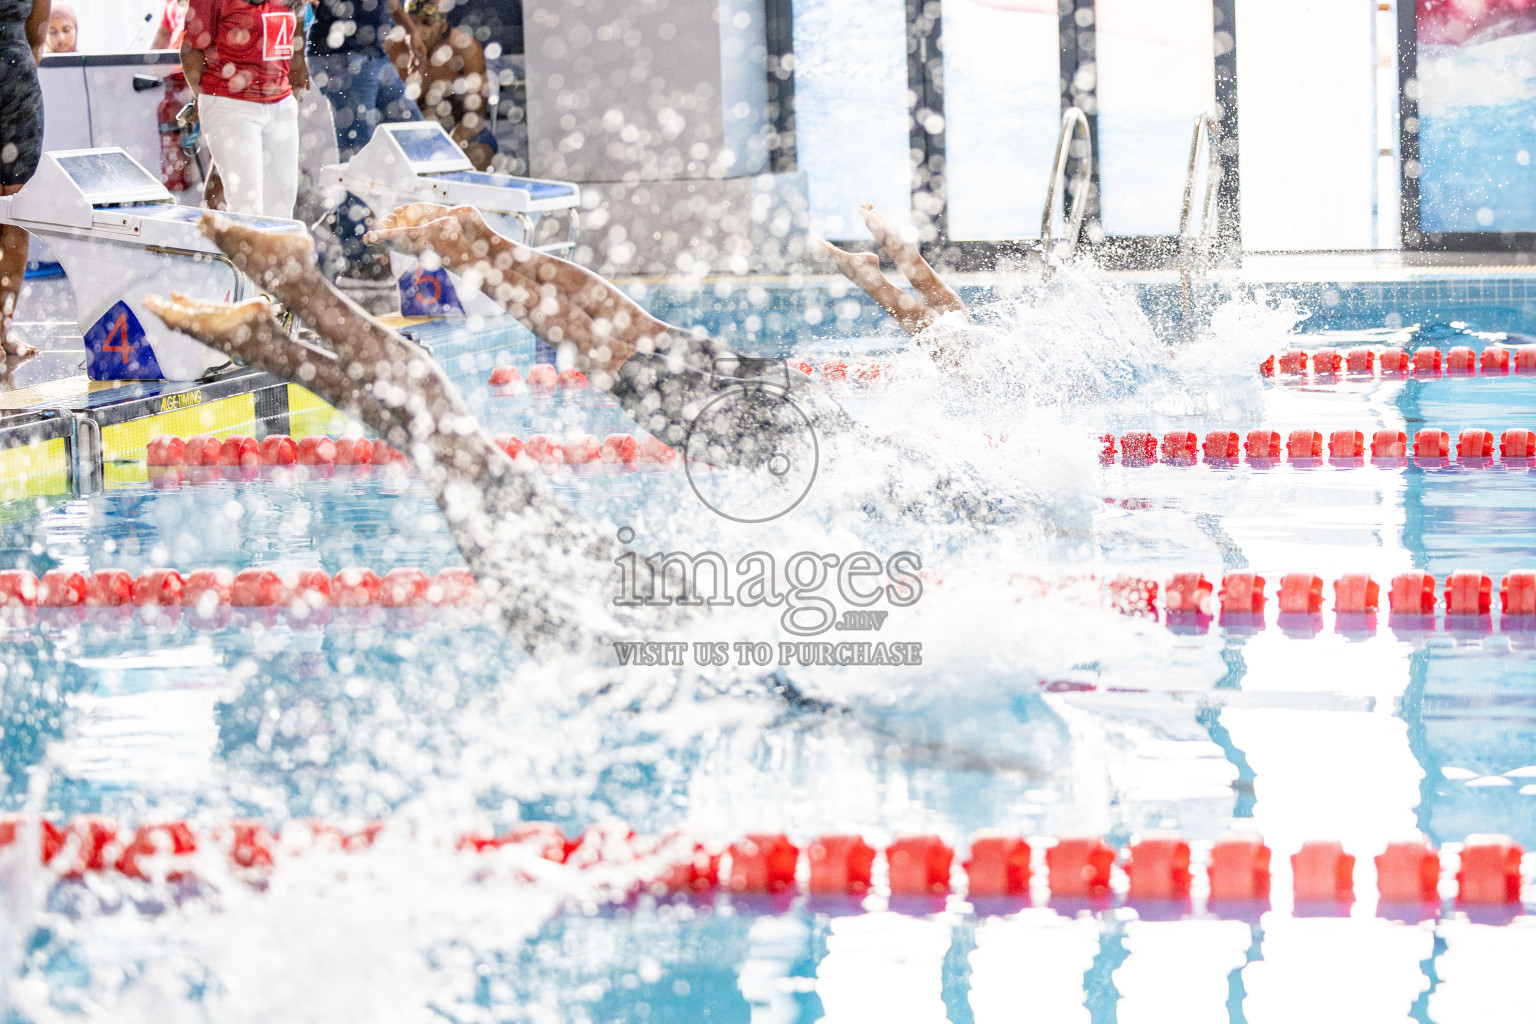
[0,0,49,387]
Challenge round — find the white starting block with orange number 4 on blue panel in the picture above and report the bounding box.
[0,149,306,381]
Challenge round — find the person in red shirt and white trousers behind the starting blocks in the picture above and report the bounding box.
[181,0,309,218]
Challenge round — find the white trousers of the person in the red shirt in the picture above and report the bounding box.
[197,92,298,218]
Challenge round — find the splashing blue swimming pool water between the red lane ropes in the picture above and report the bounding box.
[0,268,1536,1022]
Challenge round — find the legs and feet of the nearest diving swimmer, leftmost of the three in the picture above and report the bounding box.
[145,216,648,654]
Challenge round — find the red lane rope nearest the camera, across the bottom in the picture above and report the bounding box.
[0,815,1524,906]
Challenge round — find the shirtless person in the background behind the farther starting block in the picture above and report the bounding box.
[384,0,498,170]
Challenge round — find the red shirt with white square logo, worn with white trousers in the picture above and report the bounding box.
[186,0,304,103]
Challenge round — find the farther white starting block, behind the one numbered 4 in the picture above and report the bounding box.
[326,121,581,316]
